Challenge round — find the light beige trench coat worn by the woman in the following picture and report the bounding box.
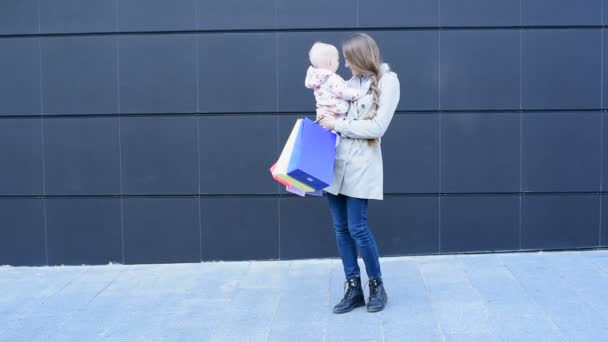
[325,67,401,200]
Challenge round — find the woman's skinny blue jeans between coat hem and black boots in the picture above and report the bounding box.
[327,193,382,279]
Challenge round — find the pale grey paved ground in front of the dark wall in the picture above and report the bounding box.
[0,250,608,342]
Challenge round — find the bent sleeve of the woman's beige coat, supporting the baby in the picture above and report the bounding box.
[334,73,401,139]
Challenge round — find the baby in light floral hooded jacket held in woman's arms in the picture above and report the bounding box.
[304,42,371,120]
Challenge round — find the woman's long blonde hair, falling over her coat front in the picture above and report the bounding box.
[342,33,380,119]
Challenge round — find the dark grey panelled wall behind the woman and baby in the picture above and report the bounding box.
[0,0,608,265]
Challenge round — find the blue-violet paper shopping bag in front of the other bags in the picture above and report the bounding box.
[287,118,336,190]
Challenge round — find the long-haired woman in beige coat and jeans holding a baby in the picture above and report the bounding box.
[320,33,400,313]
